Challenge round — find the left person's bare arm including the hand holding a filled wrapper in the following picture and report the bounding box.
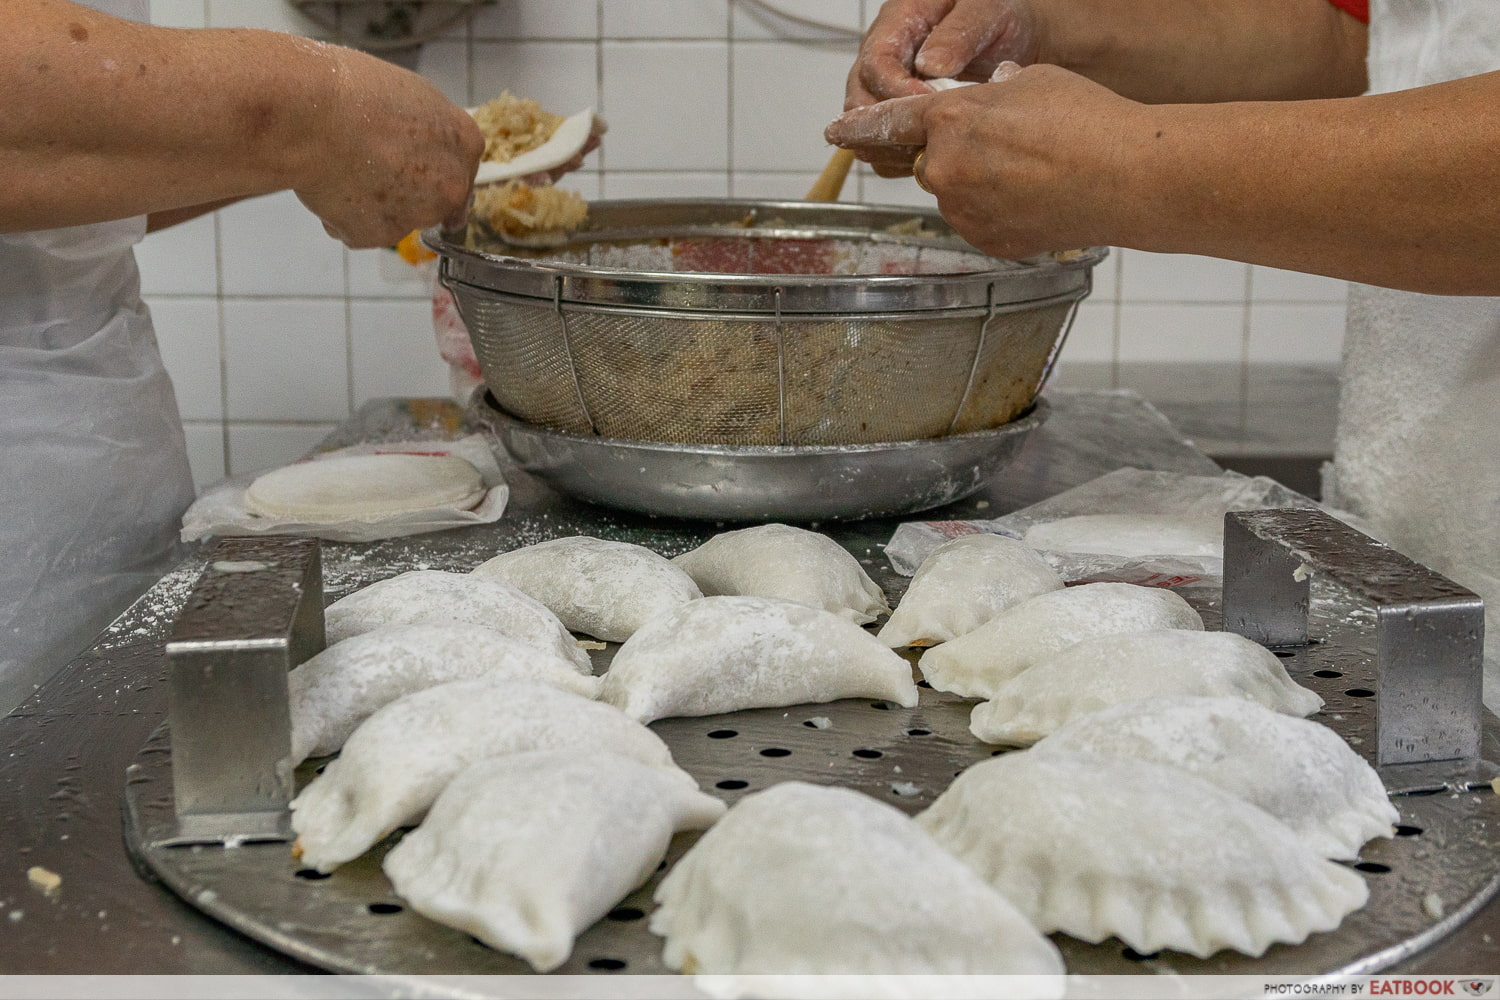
[0,0,483,246]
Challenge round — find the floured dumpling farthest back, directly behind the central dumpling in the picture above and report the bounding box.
[672,525,891,625]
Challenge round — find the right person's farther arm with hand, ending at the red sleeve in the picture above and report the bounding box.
[845,0,1365,108]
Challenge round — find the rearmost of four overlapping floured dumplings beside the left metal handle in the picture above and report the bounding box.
[323,570,594,673]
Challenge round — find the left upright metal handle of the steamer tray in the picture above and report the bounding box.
[158,537,326,844]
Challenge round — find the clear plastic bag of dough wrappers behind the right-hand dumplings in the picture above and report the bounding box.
[885,468,1319,586]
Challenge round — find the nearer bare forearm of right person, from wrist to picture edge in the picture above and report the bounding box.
[1113,73,1500,295]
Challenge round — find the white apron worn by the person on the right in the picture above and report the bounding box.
[1325,0,1500,711]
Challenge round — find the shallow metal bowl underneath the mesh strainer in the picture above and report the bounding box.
[468,391,1049,522]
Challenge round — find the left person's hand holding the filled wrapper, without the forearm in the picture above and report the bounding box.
[293,45,485,249]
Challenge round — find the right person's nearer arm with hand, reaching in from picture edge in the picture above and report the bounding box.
[827,66,1500,295]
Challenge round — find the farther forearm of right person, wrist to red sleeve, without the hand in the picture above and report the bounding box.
[1034,0,1367,103]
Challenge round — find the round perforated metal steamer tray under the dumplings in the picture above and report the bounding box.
[125,588,1500,997]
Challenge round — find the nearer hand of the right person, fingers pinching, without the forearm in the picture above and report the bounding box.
[824,63,1140,259]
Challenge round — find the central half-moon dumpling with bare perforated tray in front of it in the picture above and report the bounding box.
[599,597,917,723]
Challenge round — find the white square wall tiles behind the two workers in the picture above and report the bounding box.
[140,0,1344,483]
